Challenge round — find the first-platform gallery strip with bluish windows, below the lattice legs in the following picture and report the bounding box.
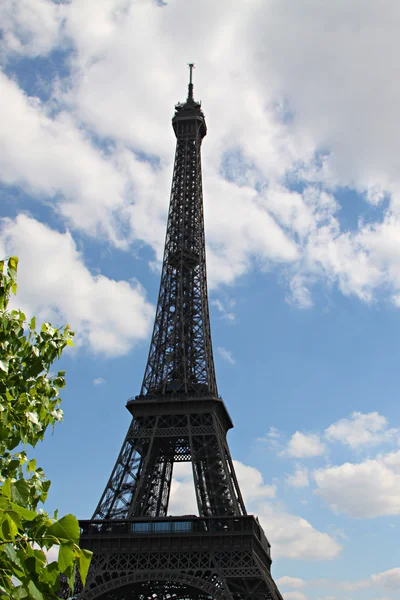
[79,515,271,556]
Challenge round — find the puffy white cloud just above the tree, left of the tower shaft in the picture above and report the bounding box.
[0,215,153,355]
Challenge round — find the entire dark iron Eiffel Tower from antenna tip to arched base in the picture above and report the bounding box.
[80,64,283,600]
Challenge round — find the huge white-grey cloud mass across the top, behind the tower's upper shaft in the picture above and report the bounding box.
[4,0,400,307]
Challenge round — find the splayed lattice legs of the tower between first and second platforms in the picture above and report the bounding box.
[93,405,246,519]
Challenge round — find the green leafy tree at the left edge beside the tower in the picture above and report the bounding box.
[0,256,91,600]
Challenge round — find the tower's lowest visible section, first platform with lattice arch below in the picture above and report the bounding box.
[80,515,283,600]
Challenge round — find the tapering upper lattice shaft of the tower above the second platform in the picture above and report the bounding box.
[141,103,217,397]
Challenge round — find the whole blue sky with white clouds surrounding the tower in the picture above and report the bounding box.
[0,0,400,600]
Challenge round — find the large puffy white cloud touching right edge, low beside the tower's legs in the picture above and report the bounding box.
[314,451,400,518]
